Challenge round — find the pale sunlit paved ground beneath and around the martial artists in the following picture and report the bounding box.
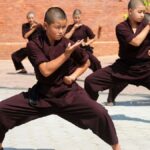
[0,56,150,150]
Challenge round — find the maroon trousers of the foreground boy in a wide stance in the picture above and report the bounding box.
[0,88,118,145]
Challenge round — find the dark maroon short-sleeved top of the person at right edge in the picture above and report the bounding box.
[112,20,150,82]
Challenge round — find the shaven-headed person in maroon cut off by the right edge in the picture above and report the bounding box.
[85,0,150,103]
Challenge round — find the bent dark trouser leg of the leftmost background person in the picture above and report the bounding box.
[11,47,28,70]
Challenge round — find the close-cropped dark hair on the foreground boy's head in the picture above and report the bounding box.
[44,7,67,24]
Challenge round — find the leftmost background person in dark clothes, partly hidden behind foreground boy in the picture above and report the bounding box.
[11,12,43,73]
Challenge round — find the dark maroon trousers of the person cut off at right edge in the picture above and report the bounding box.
[84,66,150,102]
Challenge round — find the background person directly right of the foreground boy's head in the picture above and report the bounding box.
[65,9,101,72]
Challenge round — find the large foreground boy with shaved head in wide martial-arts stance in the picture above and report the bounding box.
[0,7,120,150]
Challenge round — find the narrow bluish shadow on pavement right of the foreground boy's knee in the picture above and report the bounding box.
[111,114,150,123]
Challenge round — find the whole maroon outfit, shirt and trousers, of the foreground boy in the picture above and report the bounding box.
[0,33,118,145]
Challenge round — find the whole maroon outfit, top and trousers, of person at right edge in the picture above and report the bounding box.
[85,20,150,100]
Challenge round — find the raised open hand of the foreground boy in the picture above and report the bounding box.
[65,40,83,56]
